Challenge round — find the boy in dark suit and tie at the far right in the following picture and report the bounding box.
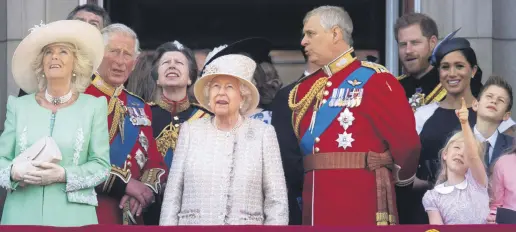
[473,76,513,167]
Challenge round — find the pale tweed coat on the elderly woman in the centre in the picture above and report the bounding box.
[160,118,288,225]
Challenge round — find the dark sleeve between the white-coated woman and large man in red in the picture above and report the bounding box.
[271,81,304,225]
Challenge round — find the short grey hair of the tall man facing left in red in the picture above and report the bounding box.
[303,6,353,46]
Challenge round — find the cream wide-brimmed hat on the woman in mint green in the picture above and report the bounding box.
[12,20,104,93]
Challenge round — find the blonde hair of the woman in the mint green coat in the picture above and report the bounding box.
[32,42,93,93]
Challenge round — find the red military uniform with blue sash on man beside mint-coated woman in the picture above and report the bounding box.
[85,75,166,225]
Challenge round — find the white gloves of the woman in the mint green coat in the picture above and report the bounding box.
[23,162,65,185]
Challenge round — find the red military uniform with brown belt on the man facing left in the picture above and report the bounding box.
[289,48,420,225]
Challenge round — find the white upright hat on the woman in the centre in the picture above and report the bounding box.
[194,54,260,115]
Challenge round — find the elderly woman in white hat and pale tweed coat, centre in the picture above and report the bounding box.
[160,55,288,225]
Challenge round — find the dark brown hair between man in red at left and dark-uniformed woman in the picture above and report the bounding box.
[126,52,156,102]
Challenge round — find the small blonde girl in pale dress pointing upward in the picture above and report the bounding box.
[423,98,489,225]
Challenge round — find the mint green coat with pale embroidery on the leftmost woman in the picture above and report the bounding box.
[0,94,110,226]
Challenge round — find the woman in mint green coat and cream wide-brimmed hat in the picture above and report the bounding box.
[0,20,110,226]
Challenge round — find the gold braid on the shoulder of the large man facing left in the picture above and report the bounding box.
[288,77,328,139]
